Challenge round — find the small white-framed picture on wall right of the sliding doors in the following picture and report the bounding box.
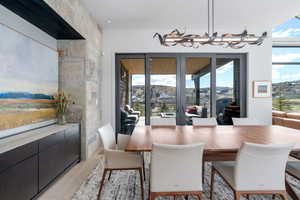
[253,80,272,98]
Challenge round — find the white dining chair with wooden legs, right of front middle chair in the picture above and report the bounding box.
[210,143,293,200]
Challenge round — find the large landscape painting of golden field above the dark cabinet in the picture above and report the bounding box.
[0,25,58,132]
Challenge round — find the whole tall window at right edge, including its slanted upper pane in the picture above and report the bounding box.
[272,16,300,112]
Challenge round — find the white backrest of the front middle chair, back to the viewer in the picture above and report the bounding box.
[150,144,204,192]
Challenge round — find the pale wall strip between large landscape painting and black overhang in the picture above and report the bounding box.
[0,5,57,50]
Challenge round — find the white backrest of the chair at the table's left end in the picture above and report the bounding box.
[98,124,116,150]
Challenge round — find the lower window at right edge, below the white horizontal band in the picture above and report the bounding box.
[272,47,300,112]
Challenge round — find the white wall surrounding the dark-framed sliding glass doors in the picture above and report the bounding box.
[102,29,272,125]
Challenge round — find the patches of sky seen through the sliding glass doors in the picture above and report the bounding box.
[132,62,233,88]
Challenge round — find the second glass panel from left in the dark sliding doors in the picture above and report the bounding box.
[146,54,179,124]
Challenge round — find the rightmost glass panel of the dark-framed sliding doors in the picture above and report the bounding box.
[216,56,247,125]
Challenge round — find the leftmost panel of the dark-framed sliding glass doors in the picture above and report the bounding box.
[115,54,146,134]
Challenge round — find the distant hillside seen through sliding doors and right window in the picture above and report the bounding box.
[132,80,300,115]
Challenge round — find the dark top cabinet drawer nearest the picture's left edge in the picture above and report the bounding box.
[0,142,38,172]
